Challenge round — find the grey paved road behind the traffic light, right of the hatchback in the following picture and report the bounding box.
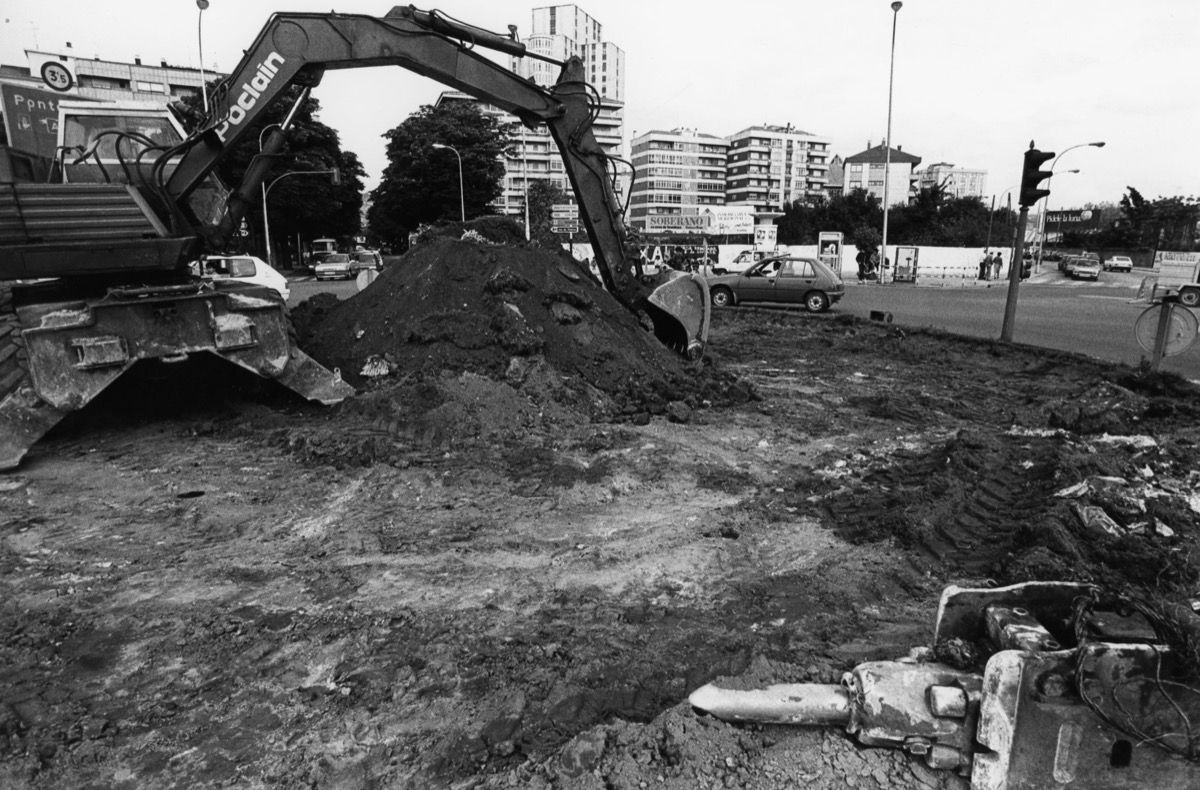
[836,271,1200,381]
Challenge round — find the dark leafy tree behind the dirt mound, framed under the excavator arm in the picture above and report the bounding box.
[367,102,509,249]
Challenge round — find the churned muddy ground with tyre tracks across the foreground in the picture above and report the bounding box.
[0,236,1200,790]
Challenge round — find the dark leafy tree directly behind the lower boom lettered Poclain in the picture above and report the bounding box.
[176,86,366,261]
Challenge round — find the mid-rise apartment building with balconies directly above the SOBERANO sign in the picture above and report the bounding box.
[626,128,730,233]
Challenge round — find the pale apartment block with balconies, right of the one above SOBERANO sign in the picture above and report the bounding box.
[725,124,829,213]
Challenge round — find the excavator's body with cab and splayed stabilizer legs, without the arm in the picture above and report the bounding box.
[0,101,354,469]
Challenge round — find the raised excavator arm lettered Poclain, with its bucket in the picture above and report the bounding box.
[166,6,709,358]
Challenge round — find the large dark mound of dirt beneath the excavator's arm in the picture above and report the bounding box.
[301,239,751,415]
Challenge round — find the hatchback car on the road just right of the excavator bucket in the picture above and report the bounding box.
[707,256,846,312]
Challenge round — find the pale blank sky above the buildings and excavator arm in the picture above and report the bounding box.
[0,0,1200,210]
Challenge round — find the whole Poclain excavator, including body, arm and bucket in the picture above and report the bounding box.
[0,6,709,469]
